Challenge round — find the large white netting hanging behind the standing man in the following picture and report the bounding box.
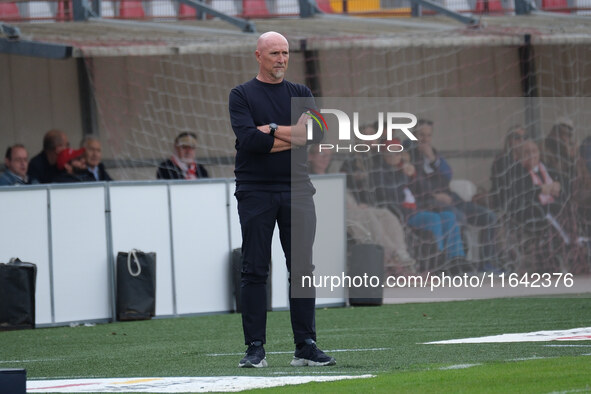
[82,29,591,272]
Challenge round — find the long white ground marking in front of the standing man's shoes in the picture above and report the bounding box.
[27,375,374,393]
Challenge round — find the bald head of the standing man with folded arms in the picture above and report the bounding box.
[255,36,289,82]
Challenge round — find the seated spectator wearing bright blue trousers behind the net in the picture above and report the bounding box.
[372,139,465,266]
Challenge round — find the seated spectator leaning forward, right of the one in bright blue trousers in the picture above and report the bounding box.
[411,119,498,270]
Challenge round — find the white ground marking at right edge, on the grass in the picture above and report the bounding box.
[425,327,591,344]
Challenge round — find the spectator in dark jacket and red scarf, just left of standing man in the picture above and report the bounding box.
[156,132,209,179]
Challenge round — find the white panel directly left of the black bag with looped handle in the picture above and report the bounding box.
[50,186,111,323]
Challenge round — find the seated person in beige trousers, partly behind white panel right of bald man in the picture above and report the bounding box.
[308,144,415,274]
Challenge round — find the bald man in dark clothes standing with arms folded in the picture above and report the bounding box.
[229,32,336,368]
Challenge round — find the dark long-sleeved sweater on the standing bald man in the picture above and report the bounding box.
[229,78,322,191]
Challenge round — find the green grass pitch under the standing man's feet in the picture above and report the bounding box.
[0,295,591,393]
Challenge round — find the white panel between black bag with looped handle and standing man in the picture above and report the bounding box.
[170,181,233,314]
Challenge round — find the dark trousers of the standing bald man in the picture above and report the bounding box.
[235,191,316,345]
